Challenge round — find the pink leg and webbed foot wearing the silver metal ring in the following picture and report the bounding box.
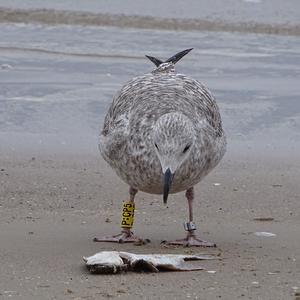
[164,187,216,247]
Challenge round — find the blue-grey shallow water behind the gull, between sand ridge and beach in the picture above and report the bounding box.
[0,23,300,156]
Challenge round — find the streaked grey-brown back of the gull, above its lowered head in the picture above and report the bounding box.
[102,64,223,135]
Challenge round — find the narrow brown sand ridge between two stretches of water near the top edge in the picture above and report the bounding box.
[0,7,300,36]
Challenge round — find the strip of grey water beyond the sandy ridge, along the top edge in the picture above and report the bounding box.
[0,0,300,24]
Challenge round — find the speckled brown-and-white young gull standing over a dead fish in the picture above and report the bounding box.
[94,49,226,247]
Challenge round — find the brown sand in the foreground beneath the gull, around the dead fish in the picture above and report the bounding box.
[0,152,300,299]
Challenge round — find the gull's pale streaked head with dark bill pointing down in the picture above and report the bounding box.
[152,113,195,203]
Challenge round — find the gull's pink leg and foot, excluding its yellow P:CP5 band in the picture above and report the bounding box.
[94,187,143,243]
